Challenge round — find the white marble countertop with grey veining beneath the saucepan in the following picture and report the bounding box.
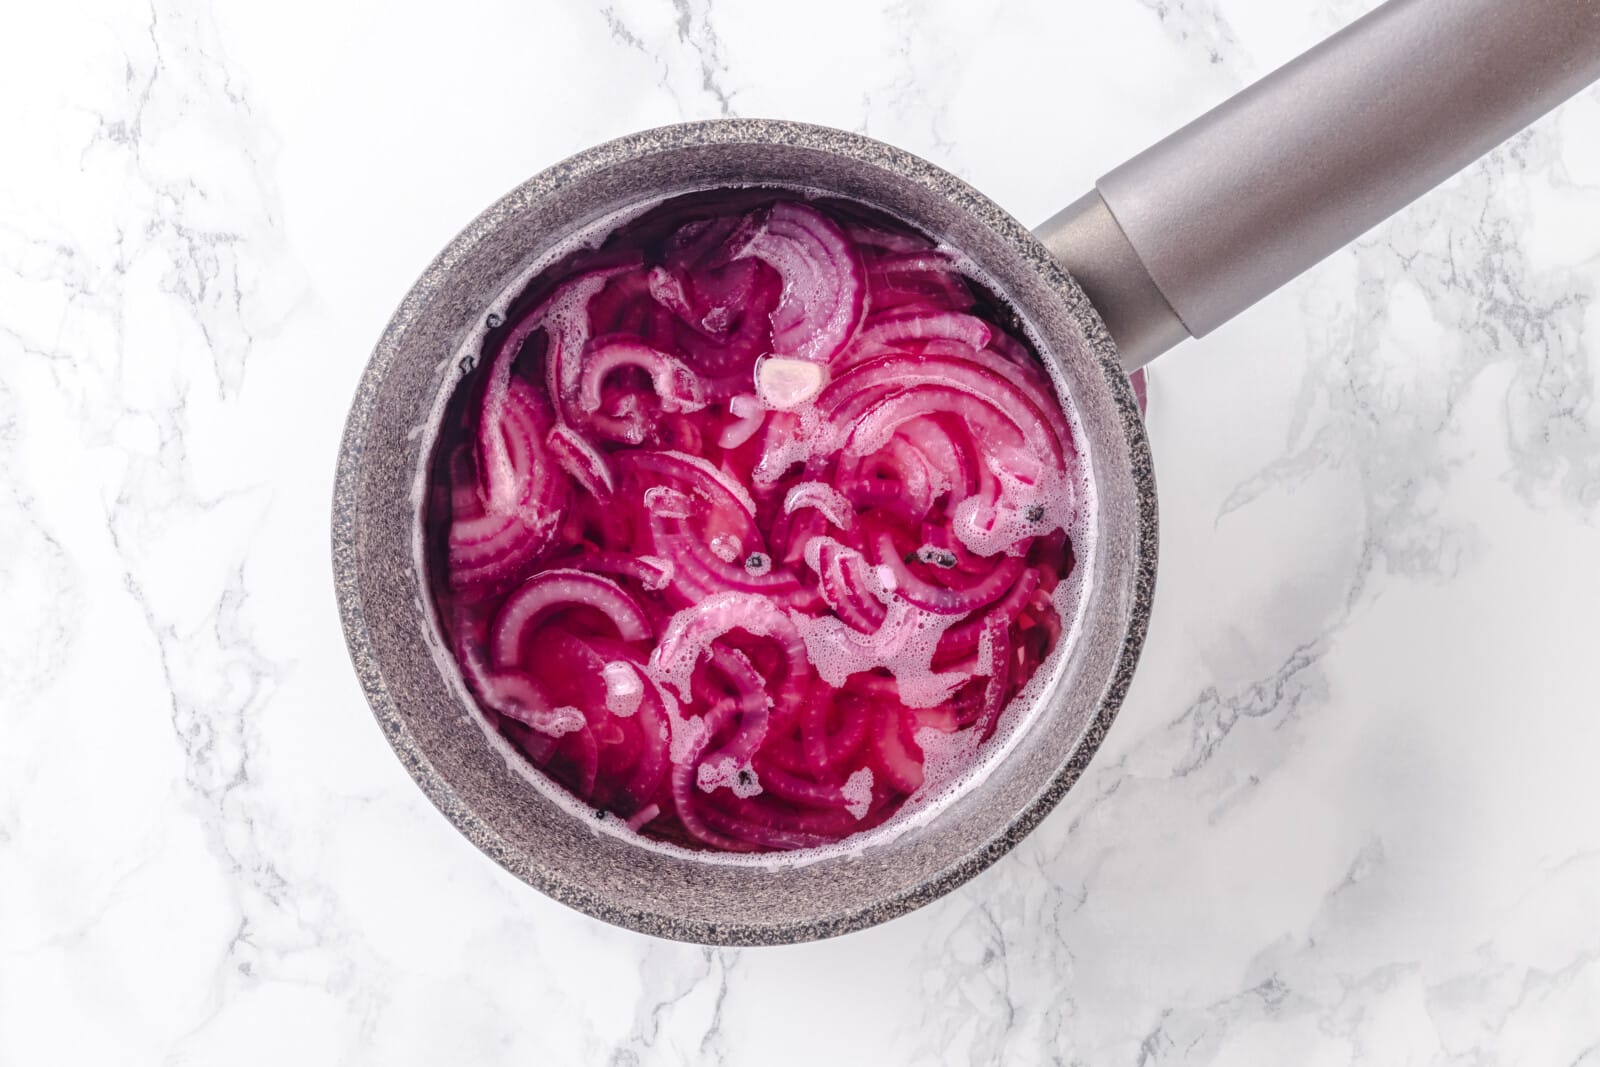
[0,0,1600,1067]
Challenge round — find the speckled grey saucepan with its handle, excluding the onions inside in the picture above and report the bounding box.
[333,0,1600,944]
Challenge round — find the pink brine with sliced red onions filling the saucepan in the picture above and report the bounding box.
[424,189,1090,853]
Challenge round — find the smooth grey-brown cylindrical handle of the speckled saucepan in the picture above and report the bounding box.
[1037,0,1600,370]
